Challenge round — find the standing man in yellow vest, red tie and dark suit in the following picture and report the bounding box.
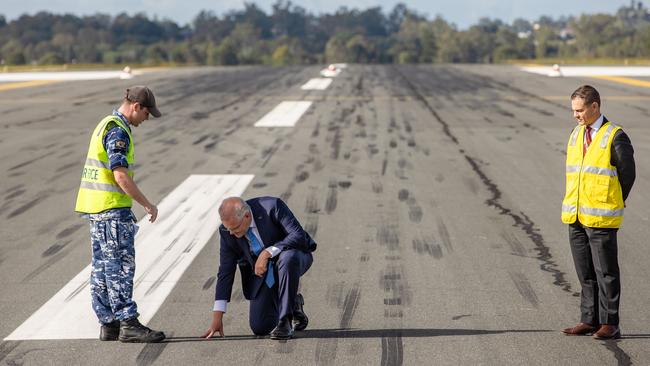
[562,85,636,339]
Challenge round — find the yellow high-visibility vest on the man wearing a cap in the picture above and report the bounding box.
[75,116,135,213]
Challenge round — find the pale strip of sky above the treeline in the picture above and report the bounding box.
[0,0,630,29]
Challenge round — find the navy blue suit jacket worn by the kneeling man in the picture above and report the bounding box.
[214,197,316,301]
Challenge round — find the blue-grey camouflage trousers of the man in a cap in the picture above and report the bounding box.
[90,220,138,324]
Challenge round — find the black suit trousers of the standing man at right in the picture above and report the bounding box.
[569,221,621,325]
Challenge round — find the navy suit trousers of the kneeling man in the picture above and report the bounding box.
[249,249,313,335]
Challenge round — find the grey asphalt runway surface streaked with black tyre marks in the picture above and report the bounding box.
[0,65,650,365]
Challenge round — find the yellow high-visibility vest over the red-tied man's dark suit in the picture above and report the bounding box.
[562,122,624,228]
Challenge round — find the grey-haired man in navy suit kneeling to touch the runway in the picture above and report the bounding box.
[203,197,316,339]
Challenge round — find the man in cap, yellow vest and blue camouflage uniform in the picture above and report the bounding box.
[75,86,165,343]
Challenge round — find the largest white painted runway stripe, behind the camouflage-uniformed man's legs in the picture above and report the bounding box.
[5,175,254,340]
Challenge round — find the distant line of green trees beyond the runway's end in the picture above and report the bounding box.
[0,0,650,65]
